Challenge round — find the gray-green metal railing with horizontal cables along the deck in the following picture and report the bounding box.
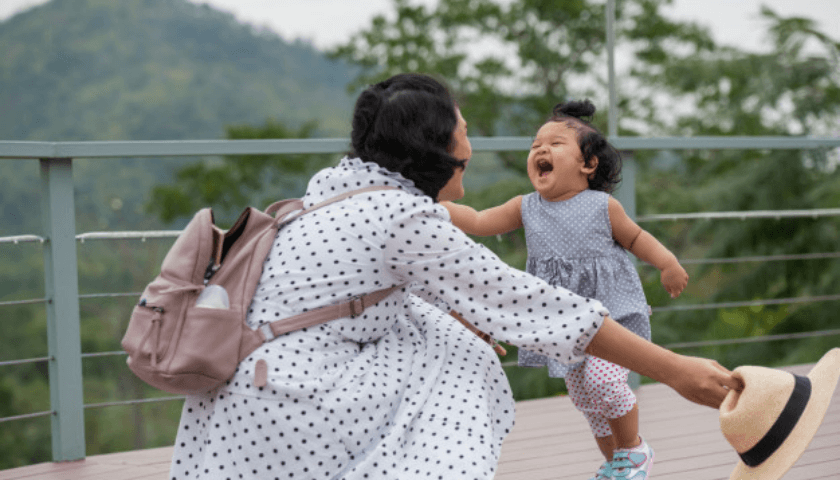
[0,137,840,461]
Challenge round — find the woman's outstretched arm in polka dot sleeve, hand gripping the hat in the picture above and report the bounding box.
[383,204,737,406]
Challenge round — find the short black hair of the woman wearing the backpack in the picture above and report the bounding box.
[350,73,467,200]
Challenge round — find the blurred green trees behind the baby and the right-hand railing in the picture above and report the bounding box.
[330,0,840,395]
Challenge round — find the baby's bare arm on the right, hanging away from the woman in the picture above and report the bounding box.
[609,197,688,298]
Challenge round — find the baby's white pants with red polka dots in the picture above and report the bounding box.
[566,355,636,437]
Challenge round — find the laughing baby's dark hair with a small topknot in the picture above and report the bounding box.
[548,100,621,193]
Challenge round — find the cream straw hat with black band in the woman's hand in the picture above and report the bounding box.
[720,348,840,480]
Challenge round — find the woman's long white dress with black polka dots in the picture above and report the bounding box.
[170,159,607,480]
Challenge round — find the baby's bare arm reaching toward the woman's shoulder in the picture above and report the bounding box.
[440,195,522,237]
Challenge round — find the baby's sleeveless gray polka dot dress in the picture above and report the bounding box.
[519,190,650,377]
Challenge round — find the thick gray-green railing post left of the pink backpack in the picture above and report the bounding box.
[41,158,85,461]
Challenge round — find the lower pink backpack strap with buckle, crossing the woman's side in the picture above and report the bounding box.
[259,285,405,342]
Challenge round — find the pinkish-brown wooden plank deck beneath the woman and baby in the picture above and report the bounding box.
[0,365,840,480]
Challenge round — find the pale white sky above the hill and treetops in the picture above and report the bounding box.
[0,0,840,50]
